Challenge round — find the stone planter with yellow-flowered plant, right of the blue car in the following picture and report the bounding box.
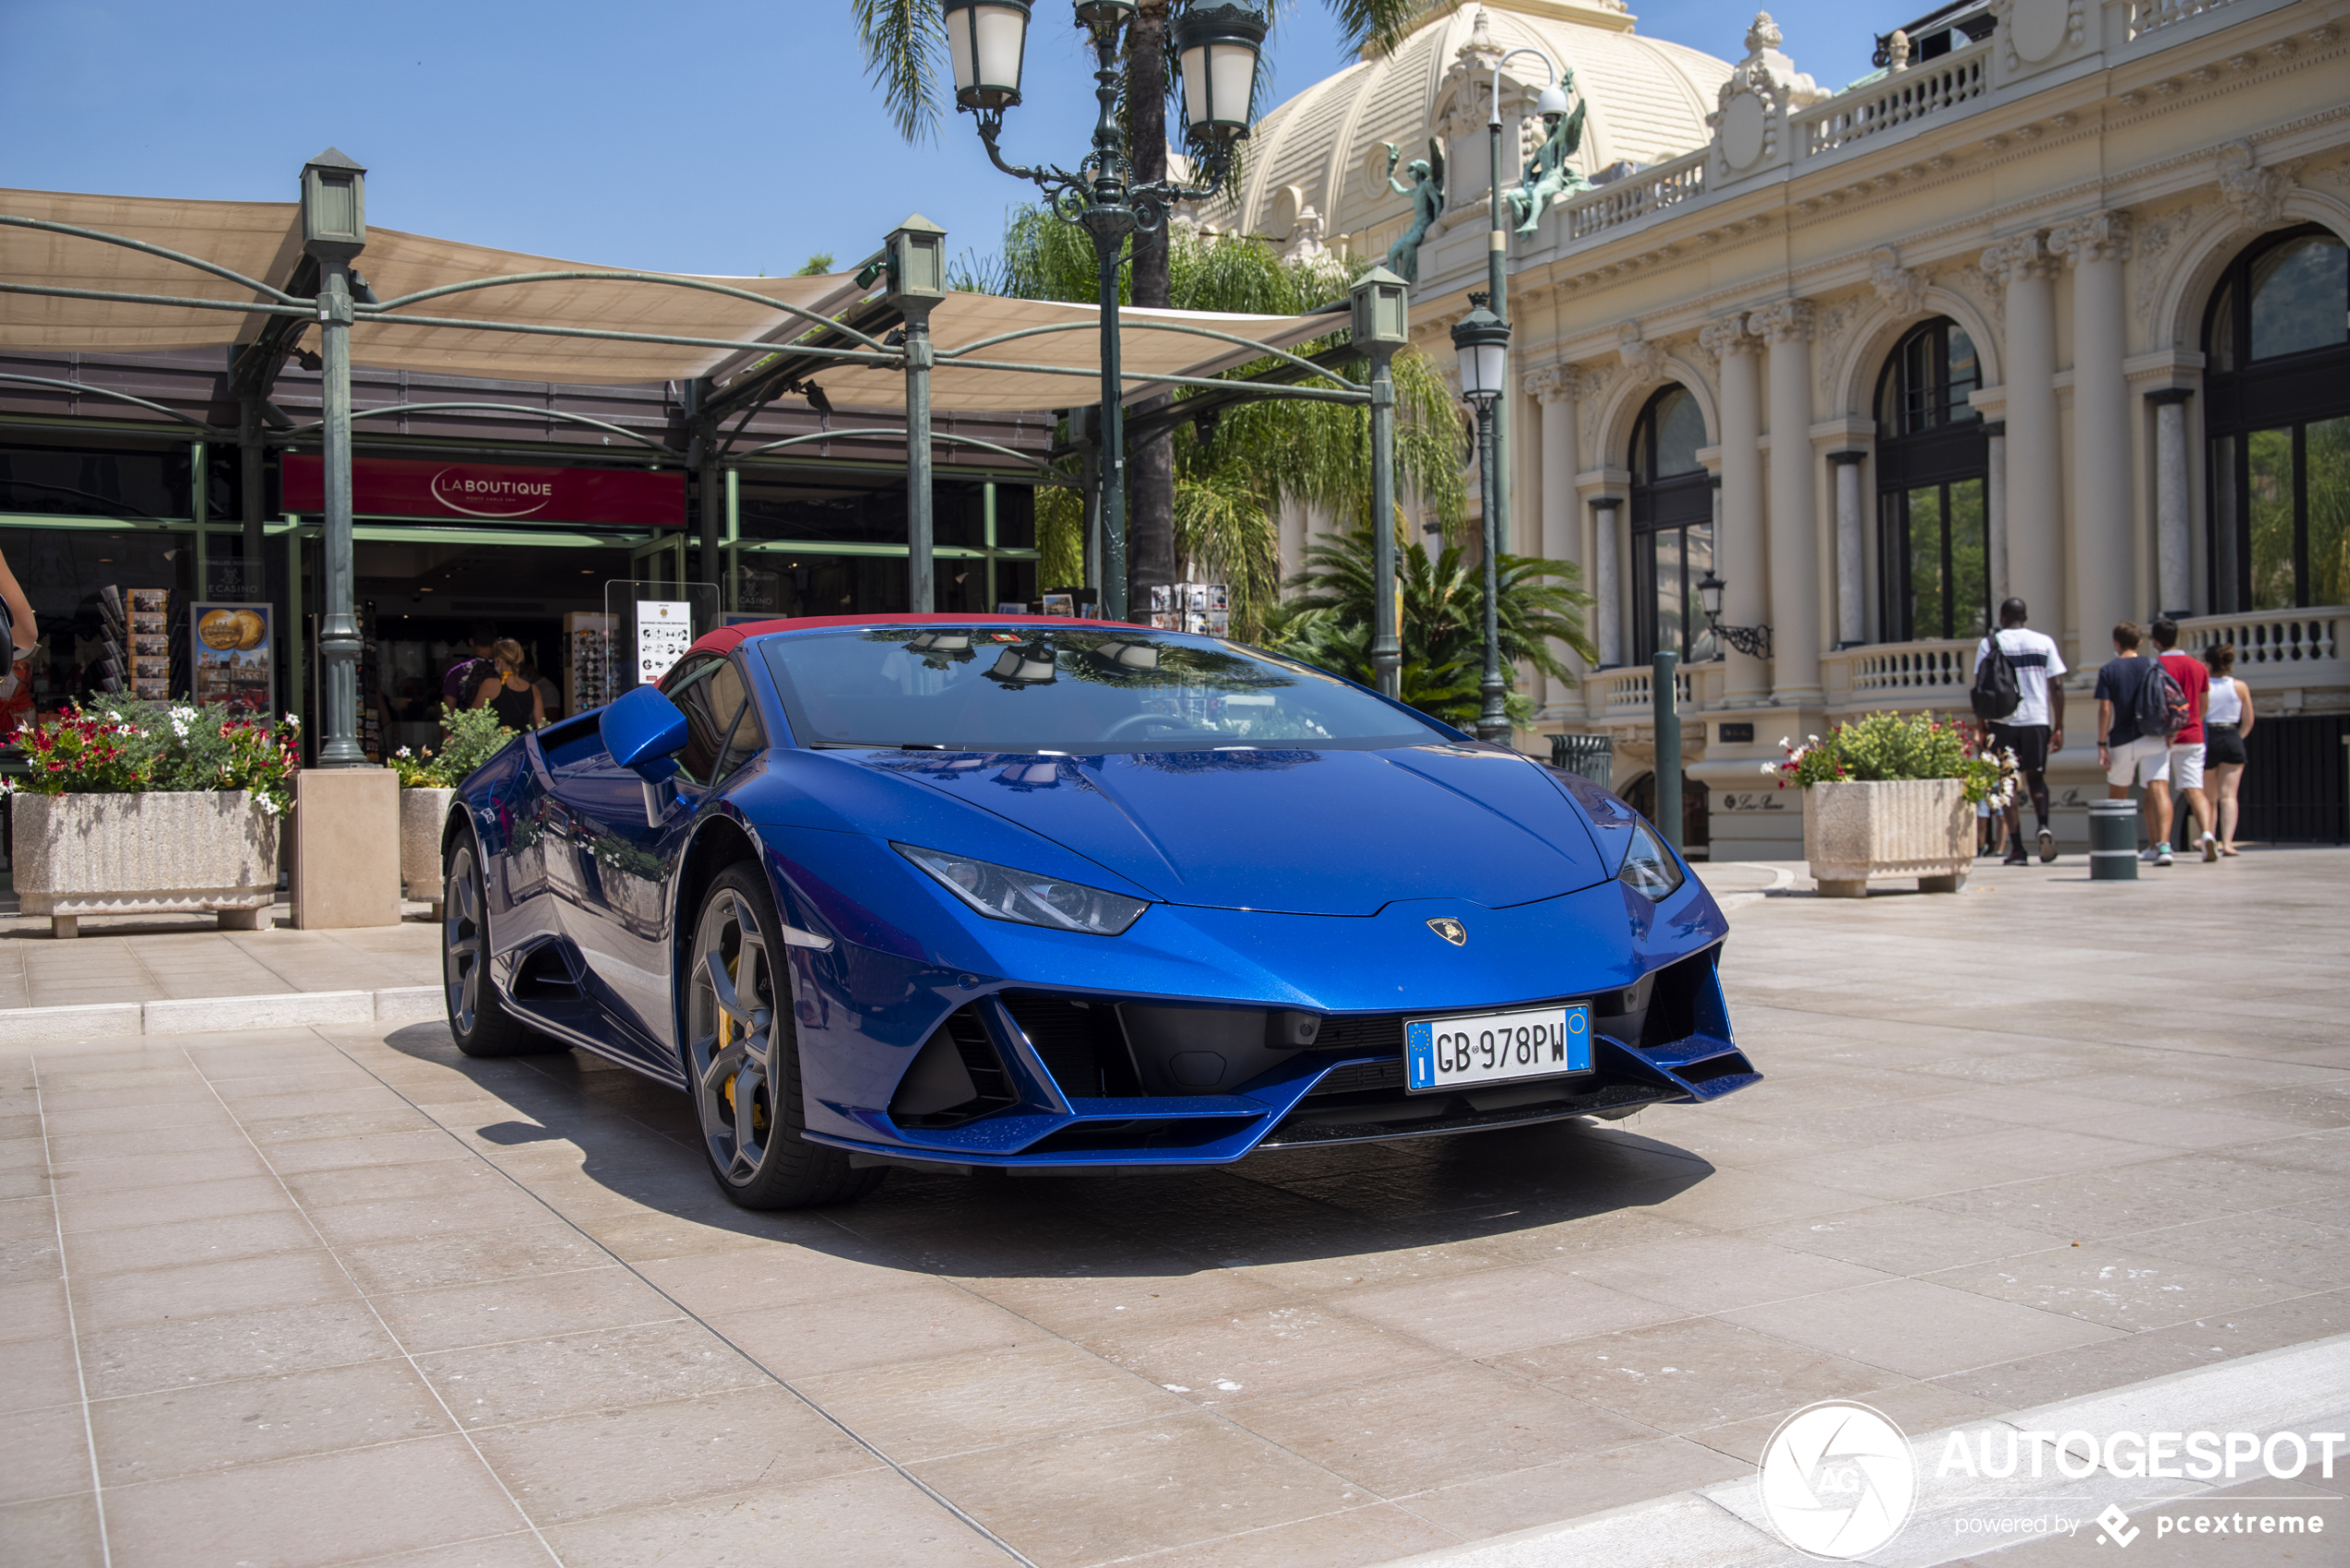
[1762,712,2014,898]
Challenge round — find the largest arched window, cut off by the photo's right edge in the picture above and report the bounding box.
[2205,223,2350,613]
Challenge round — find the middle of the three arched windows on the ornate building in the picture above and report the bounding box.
[1877,315,1990,642]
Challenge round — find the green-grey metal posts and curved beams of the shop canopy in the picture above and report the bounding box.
[0,148,1405,766]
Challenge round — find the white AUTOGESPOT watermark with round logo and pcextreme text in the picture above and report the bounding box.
[1760,1399,2350,1561]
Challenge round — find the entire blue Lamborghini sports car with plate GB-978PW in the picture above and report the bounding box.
[444,616,1758,1208]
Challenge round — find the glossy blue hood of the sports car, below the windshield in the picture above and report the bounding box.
[865,746,1612,915]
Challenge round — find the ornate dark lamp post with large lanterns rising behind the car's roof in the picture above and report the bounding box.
[943,0,1265,621]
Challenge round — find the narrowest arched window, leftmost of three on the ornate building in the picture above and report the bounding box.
[1631,386,1715,663]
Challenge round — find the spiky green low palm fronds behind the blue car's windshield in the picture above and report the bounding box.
[1265,529,1596,726]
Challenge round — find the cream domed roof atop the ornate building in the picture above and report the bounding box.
[1206,0,1729,253]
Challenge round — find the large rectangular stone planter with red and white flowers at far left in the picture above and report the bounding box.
[0,698,301,938]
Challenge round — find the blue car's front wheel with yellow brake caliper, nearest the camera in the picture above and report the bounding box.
[684,863,884,1208]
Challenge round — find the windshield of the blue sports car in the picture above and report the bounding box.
[764,625,1448,752]
